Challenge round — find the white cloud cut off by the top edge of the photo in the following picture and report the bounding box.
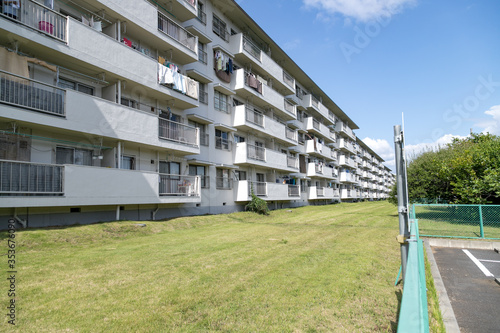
[303,0,416,22]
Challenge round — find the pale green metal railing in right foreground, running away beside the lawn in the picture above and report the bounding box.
[398,220,429,333]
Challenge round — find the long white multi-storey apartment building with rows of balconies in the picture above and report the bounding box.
[0,0,394,227]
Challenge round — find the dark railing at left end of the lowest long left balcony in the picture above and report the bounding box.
[0,160,64,196]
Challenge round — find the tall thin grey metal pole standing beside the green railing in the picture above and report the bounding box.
[394,125,410,282]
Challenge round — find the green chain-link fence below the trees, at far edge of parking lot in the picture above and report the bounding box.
[412,204,500,239]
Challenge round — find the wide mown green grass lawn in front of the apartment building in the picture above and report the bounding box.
[0,202,430,332]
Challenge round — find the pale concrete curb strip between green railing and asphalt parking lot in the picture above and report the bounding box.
[424,238,460,333]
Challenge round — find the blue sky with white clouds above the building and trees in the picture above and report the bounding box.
[233,0,500,167]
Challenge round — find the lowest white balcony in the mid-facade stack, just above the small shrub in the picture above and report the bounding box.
[235,180,300,202]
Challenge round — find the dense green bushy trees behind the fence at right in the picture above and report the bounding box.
[390,134,500,204]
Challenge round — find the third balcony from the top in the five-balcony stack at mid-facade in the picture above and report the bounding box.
[233,105,297,145]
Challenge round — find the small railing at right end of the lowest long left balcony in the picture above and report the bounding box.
[159,173,200,197]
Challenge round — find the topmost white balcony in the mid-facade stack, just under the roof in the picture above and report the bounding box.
[229,33,295,95]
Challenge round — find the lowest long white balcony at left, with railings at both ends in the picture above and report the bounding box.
[0,160,201,208]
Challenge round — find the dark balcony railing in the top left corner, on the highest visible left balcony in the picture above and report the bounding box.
[0,0,67,42]
